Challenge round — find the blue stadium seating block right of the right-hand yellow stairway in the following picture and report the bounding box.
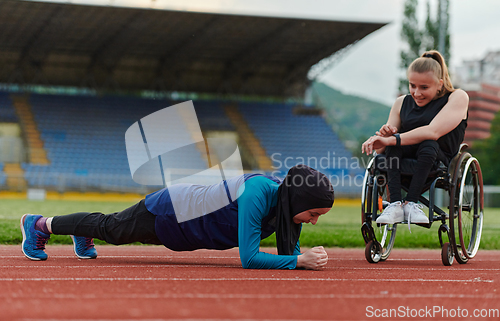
[239,103,364,194]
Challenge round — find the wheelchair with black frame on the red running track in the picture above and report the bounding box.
[361,144,484,266]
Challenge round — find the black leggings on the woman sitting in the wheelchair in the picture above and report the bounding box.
[385,140,447,203]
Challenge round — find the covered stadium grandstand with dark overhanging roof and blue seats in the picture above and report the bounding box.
[0,1,386,198]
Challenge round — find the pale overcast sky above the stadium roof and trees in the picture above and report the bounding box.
[35,0,500,105]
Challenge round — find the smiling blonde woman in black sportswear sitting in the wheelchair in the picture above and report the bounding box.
[361,50,469,224]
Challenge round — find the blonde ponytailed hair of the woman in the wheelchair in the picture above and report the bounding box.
[407,50,455,98]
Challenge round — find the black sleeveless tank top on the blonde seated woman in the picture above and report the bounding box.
[400,93,468,160]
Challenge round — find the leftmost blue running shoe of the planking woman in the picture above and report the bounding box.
[21,214,50,261]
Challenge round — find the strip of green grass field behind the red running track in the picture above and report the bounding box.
[0,200,500,250]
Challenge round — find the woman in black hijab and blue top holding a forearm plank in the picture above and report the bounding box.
[21,165,334,269]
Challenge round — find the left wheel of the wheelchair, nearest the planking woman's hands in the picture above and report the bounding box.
[361,161,397,263]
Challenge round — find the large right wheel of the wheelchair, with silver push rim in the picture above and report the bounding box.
[450,153,484,263]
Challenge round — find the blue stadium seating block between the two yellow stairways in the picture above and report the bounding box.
[24,94,238,188]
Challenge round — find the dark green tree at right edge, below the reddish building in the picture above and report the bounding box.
[471,113,500,185]
